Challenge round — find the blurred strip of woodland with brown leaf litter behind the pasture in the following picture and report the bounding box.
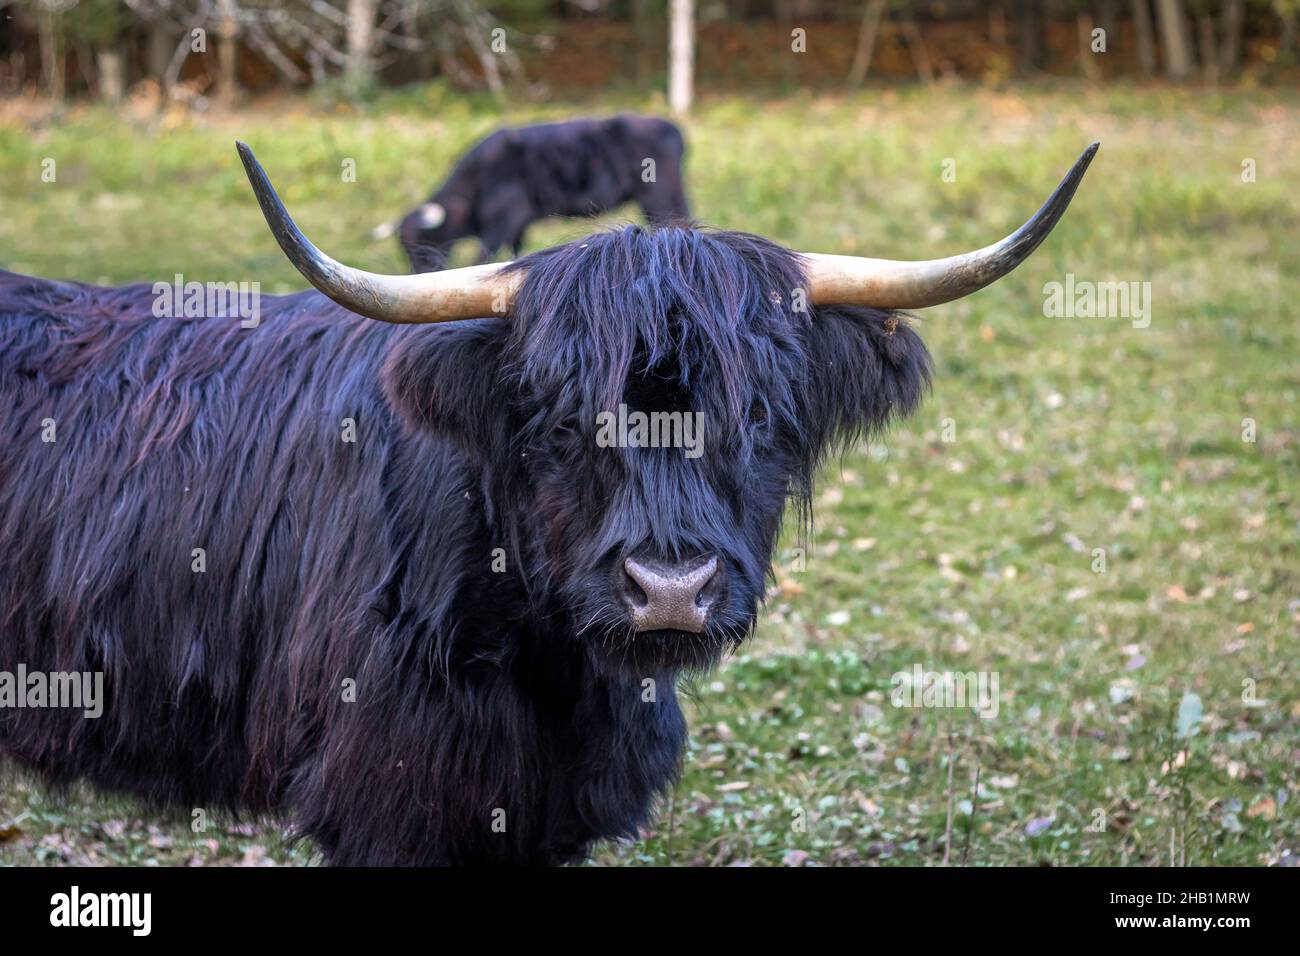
[0,0,1300,109]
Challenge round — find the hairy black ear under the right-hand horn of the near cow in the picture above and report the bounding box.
[803,306,931,457]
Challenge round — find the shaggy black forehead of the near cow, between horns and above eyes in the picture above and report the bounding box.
[512,226,807,401]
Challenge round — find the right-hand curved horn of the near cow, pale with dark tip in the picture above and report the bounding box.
[803,143,1100,308]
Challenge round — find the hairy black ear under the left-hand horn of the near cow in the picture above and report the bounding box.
[381,319,512,460]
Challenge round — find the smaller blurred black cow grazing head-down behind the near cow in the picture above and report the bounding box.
[387,116,690,272]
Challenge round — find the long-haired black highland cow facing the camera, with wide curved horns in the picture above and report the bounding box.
[0,141,1095,864]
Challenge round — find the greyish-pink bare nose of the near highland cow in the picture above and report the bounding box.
[619,554,719,633]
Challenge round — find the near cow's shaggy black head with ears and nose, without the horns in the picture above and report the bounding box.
[386,228,928,675]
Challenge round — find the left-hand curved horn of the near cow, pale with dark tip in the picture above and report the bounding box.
[237,143,524,323]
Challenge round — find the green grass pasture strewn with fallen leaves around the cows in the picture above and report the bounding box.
[0,86,1300,865]
